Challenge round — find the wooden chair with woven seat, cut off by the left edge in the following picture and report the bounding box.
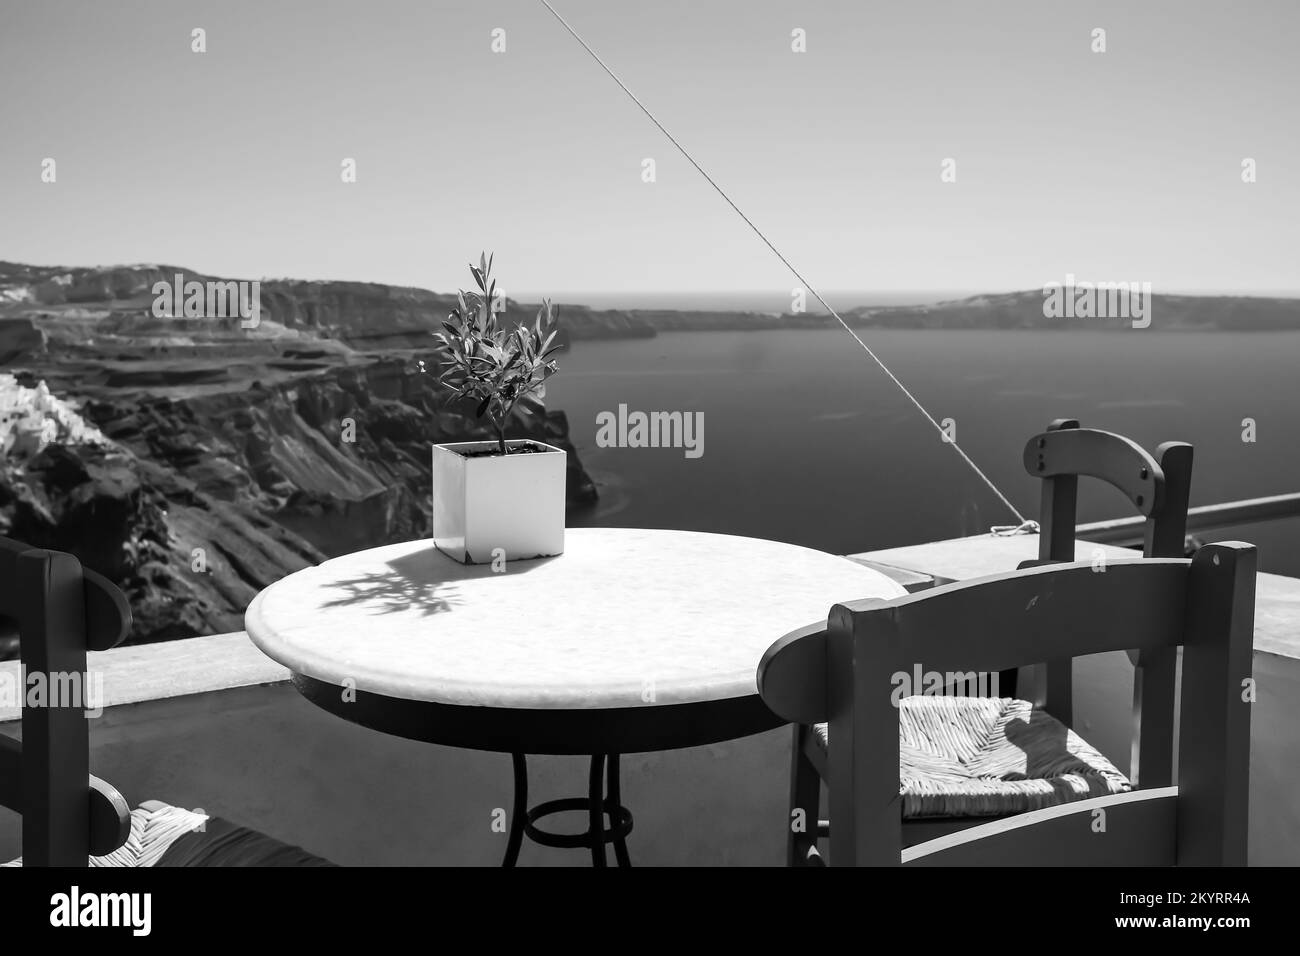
[0,537,328,866]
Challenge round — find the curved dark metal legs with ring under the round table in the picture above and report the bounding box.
[502,753,632,866]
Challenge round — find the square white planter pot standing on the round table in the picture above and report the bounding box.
[433,440,567,564]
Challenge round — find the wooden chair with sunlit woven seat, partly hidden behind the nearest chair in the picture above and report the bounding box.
[787,419,1192,865]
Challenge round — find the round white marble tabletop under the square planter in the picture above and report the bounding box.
[246,528,905,709]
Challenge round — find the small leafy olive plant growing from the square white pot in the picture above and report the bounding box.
[434,254,558,455]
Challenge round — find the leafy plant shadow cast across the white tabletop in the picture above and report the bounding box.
[324,544,560,617]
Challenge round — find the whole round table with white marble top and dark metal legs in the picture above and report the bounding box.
[246,528,905,864]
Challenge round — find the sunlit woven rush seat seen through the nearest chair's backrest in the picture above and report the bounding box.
[813,696,1132,819]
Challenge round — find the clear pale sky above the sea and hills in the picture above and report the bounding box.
[0,0,1300,295]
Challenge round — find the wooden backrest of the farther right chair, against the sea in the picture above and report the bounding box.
[1019,419,1192,787]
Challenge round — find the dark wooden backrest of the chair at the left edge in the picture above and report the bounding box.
[0,537,131,866]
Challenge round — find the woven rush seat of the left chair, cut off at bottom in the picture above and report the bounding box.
[4,801,333,866]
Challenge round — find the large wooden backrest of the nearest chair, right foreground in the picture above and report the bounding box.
[758,542,1256,866]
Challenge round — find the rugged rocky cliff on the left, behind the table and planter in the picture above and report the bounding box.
[0,264,595,650]
